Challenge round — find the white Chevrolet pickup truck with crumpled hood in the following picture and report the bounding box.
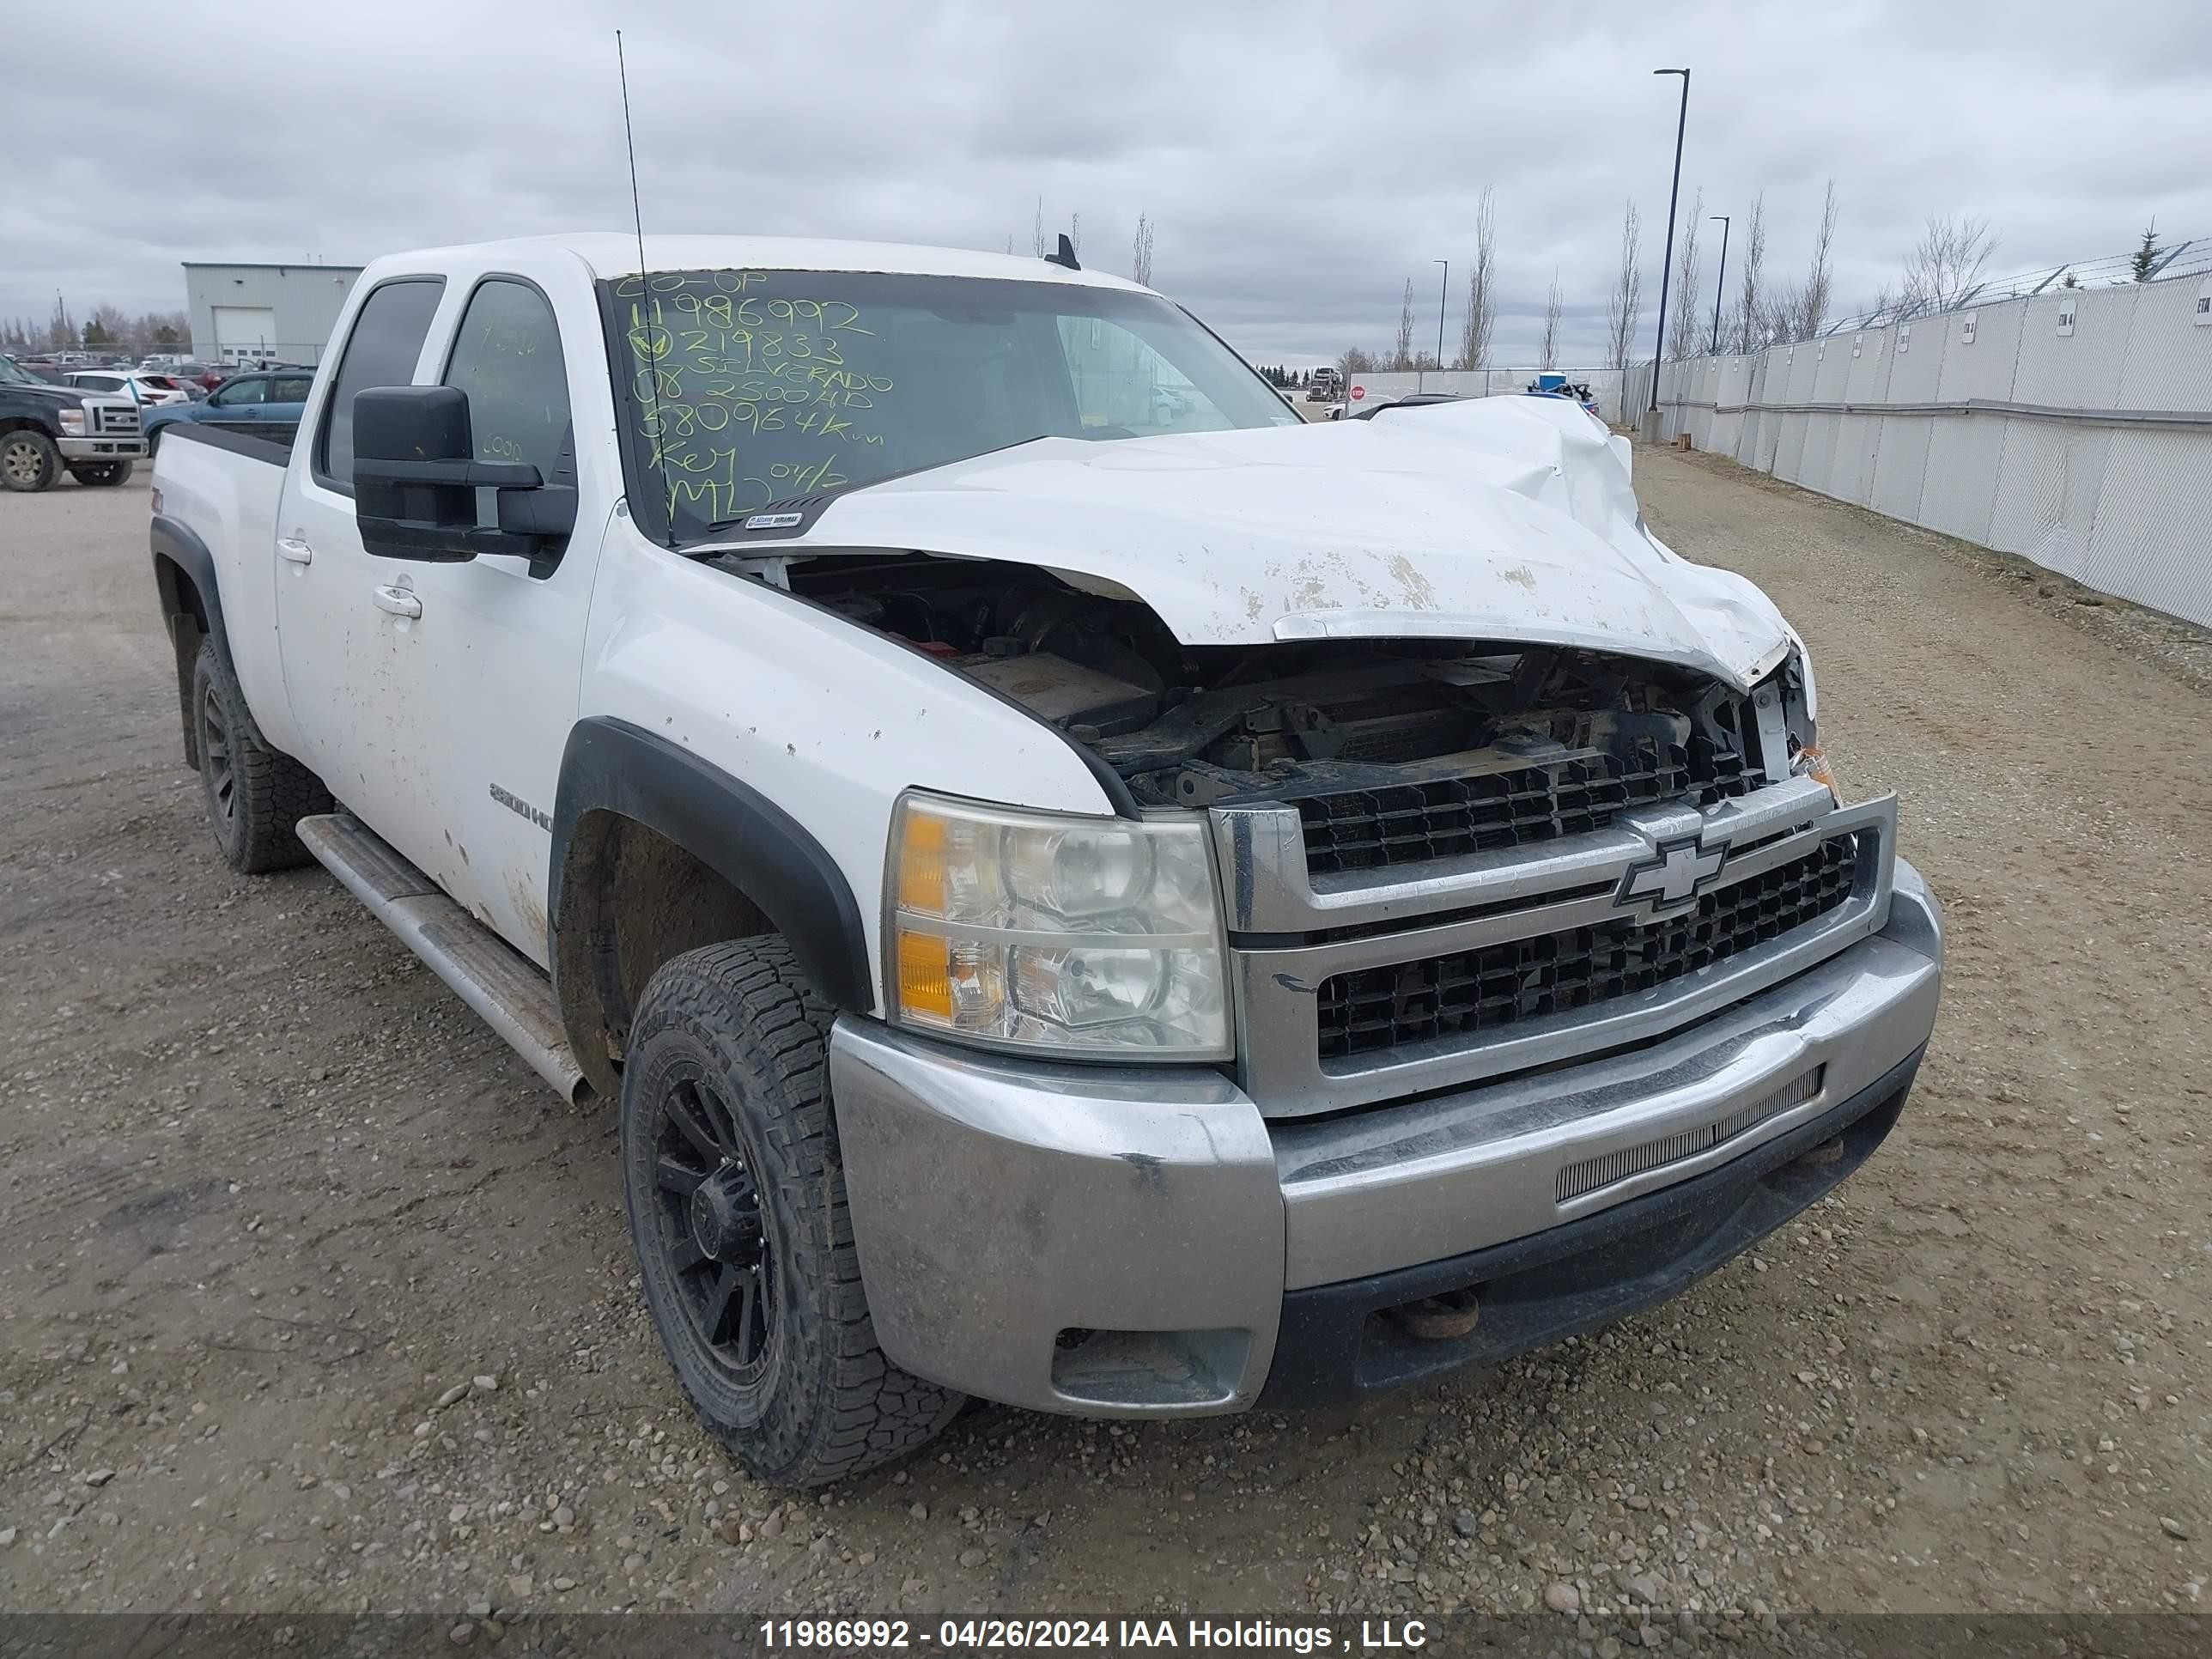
[153,234,1942,1486]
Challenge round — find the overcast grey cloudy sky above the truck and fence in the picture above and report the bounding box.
[0,0,2212,362]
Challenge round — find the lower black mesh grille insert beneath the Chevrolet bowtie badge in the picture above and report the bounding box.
[1316,836,1858,1061]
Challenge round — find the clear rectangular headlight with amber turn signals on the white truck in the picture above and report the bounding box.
[884,794,1232,1060]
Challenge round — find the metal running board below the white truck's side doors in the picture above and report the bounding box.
[299,811,592,1103]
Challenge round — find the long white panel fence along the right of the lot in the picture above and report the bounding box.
[1626,272,2212,626]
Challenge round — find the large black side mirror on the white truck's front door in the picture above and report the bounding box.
[354,385,575,564]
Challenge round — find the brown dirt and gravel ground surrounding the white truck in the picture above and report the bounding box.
[0,452,2212,1650]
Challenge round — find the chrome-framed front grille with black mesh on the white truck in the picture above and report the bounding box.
[1212,776,1898,1117]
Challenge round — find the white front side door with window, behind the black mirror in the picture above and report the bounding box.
[279,274,611,967]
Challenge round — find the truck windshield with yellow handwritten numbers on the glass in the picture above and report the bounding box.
[602,270,1298,542]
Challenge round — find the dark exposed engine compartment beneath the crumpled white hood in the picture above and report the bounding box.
[785,556,1769,865]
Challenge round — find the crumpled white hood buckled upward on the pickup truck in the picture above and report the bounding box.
[745,396,1790,688]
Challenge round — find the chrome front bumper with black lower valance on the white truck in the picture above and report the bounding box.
[830,860,1942,1416]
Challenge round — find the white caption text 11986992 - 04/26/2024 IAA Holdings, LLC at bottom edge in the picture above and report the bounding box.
[761,1620,1429,1652]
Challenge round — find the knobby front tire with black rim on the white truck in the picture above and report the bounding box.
[622,936,964,1489]
